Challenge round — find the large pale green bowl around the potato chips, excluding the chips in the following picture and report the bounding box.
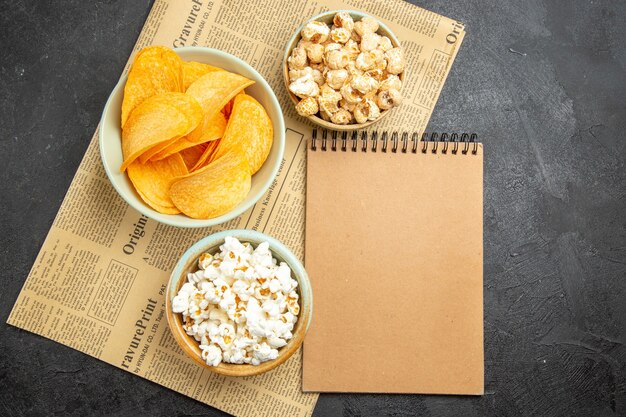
[98,47,285,227]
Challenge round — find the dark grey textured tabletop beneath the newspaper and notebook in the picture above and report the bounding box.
[0,0,626,417]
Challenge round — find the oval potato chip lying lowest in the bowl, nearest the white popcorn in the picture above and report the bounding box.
[170,149,251,219]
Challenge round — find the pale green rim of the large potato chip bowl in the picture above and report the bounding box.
[98,46,286,228]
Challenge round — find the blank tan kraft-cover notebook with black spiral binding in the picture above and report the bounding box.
[303,131,484,395]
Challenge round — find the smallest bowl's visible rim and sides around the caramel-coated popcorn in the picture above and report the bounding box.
[283,10,406,131]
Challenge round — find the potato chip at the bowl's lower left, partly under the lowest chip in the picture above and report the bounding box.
[128,154,189,214]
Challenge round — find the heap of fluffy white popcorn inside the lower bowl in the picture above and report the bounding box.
[172,237,300,366]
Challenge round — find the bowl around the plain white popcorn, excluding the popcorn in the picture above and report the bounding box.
[165,230,313,376]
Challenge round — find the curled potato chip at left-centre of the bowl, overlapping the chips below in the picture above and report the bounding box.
[120,93,202,172]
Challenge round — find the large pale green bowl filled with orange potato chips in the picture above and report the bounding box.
[99,46,285,227]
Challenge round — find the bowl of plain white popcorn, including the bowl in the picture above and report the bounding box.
[166,230,313,376]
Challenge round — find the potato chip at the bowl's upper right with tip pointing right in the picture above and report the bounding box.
[187,71,254,127]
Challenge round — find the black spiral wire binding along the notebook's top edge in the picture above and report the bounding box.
[311,129,478,155]
